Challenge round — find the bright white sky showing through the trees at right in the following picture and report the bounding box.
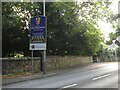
[98,0,119,41]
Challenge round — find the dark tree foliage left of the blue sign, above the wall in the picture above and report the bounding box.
[2,2,42,56]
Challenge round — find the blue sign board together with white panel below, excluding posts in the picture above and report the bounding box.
[29,16,47,50]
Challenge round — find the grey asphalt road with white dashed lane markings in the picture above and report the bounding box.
[3,62,118,90]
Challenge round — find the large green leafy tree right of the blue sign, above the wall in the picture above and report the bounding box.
[48,2,109,55]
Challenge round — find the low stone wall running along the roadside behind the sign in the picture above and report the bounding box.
[2,56,92,75]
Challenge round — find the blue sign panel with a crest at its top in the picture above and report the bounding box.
[30,16,46,42]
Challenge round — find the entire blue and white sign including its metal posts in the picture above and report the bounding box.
[29,0,47,74]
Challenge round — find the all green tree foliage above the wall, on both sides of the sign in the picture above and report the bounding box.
[2,2,111,56]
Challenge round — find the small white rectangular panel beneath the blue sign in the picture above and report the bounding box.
[29,43,46,50]
